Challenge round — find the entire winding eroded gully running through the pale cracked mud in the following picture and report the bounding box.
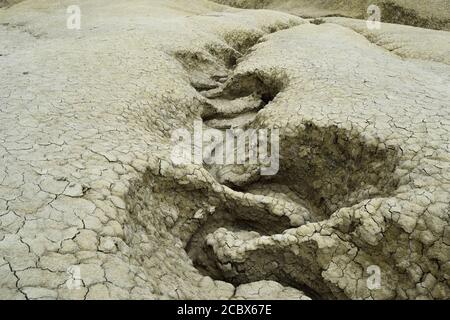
[146,23,398,299]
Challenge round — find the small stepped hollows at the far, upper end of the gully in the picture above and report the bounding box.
[175,37,287,130]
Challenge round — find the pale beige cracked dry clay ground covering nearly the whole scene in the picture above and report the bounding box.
[0,0,450,299]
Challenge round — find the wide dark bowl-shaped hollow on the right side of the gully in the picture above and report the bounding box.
[241,123,399,217]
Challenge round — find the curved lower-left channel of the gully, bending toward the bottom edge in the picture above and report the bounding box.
[125,166,340,297]
